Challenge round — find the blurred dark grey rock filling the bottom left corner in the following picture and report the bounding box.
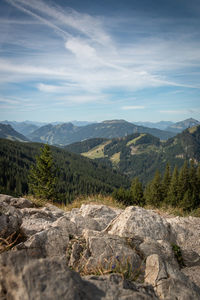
[0,251,105,300]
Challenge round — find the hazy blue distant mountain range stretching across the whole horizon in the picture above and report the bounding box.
[0,119,200,146]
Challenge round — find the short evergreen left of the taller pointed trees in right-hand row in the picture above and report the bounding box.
[131,177,145,206]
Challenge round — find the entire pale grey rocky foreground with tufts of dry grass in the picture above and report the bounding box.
[0,195,200,300]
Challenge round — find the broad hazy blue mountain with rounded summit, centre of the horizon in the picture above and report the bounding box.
[28,120,174,146]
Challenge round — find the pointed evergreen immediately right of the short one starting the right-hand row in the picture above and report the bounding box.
[145,170,163,207]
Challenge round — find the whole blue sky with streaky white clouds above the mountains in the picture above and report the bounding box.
[0,0,200,122]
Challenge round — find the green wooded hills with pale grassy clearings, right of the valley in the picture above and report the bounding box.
[65,126,200,182]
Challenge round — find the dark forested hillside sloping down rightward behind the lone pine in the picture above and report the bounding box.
[0,139,130,202]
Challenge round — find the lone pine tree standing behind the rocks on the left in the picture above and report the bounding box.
[29,145,56,200]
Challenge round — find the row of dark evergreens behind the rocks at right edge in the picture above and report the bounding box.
[113,160,200,211]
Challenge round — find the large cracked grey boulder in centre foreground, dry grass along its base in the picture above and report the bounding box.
[67,230,142,277]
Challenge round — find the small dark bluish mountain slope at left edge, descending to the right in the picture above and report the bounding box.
[0,123,28,142]
